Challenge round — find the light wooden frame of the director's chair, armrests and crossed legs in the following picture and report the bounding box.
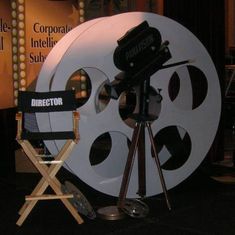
[16,91,84,226]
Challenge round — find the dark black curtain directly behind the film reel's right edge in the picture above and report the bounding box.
[164,0,225,161]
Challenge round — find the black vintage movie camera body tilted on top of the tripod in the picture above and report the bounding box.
[106,21,171,99]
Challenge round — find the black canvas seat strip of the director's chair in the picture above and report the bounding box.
[21,131,76,140]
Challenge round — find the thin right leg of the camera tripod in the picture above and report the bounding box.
[146,122,171,210]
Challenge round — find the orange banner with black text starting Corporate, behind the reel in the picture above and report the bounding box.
[18,0,79,90]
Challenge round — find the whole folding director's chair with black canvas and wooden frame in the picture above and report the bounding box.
[16,90,83,226]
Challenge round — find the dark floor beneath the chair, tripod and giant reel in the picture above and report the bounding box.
[0,163,235,235]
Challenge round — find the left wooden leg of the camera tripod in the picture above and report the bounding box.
[118,123,141,208]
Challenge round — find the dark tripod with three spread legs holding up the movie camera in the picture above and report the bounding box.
[117,79,171,210]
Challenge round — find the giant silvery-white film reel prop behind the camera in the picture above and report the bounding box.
[36,12,221,197]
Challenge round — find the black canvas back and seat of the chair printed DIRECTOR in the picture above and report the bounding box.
[18,90,76,140]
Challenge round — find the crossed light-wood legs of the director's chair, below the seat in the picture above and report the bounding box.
[16,140,83,226]
